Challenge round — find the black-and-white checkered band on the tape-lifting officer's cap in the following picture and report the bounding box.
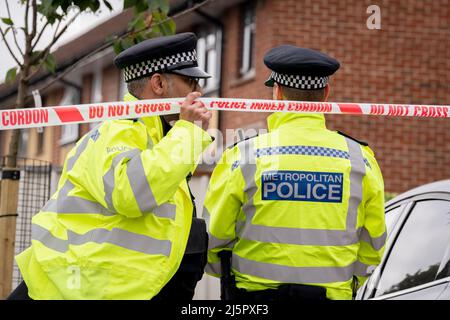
[123,50,197,82]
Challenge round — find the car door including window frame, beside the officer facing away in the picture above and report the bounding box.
[371,197,450,300]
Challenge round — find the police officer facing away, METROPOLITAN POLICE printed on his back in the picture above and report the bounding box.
[204,45,386,301]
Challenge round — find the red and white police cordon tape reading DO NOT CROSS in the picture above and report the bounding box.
[0,98,450,130]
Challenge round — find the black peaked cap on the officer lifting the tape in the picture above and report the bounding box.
[114,32,211,82]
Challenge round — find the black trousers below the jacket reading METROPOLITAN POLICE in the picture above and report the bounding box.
[232,284,328,302]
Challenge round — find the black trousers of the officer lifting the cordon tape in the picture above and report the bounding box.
[7,218,208,302]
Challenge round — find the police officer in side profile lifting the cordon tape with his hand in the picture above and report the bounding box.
[10,33,211,300]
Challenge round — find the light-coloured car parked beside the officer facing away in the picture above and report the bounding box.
[356,180,450,300]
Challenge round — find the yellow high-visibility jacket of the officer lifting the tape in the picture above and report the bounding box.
[16,94,211,299]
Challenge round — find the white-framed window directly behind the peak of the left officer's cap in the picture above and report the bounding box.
[197,27,222,96]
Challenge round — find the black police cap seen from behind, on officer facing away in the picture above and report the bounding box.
[264,45,340,90]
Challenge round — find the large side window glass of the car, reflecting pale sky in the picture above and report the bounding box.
[376,200,450,296]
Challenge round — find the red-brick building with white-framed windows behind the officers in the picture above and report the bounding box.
[0,0,450,298]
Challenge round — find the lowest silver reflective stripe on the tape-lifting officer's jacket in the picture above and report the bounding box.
[32,224,171,256]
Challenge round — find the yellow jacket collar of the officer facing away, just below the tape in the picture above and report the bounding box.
[267,112,326,131]
